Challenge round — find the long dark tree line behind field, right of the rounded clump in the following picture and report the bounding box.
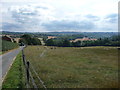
[45,35,120,47]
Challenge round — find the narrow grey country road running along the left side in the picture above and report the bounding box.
[0,47,23,79]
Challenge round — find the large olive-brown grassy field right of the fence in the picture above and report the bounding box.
[25,46,118,88]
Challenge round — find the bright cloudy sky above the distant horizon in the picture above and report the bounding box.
[0,0,119,32]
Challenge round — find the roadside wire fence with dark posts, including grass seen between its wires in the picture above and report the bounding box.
[22,48,47,90]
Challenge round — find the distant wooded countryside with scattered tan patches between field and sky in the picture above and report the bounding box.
[0,31,120,47]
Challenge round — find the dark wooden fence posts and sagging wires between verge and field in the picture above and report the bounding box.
[22,48,47,90]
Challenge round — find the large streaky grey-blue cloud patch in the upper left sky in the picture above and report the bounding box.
[10,5,49,25]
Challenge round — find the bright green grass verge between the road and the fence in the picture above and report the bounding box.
[2,53,25,89]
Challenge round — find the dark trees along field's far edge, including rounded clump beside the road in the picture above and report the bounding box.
[19,34,120,47]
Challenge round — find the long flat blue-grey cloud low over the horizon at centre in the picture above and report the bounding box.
[42,20,95,30]
